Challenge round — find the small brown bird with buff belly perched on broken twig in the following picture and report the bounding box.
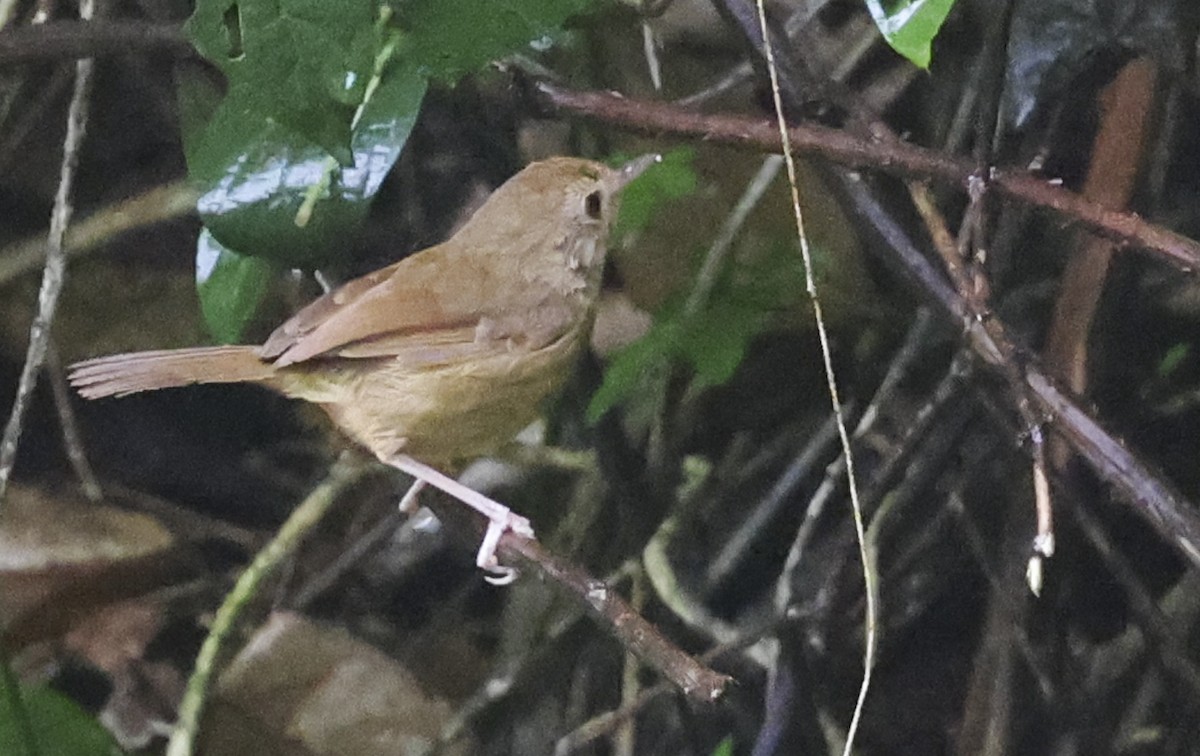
[70,155,660,578]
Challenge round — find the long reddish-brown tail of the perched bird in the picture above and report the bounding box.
[70,347,276,398]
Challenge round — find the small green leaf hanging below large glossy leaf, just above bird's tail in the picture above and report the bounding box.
[196,229,276,344]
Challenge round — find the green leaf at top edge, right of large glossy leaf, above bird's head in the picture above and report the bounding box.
[392,0,590,80]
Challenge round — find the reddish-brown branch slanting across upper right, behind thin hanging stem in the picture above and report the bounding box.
[535,82,1200,272]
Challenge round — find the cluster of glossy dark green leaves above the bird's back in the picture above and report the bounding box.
[180,0,597,341]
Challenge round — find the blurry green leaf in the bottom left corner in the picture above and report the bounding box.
[0,685,122,756]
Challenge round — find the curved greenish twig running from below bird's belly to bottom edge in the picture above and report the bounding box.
[167,455,372,756]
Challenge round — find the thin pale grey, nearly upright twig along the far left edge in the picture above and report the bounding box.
[0,0,95,513]
